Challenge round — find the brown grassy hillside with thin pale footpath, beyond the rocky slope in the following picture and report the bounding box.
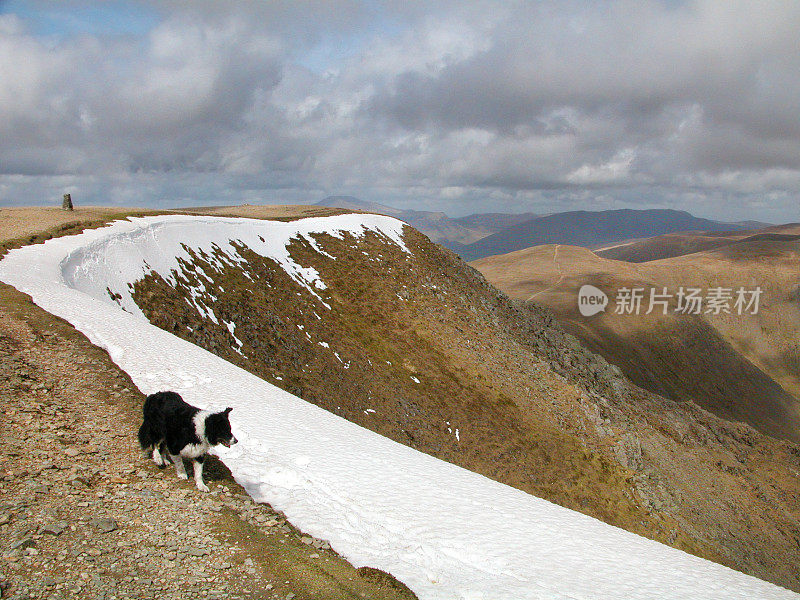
[472,238,800,439]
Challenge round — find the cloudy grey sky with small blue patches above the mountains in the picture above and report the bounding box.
[0,0,800,222]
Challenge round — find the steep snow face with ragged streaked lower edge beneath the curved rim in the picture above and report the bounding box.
[55,215,408,323]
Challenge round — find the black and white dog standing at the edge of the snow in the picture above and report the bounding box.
[139,392,236,492]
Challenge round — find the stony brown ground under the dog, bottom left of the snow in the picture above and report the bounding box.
[0,285,414,600]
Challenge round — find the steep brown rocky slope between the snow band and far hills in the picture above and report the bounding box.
[120,216,800,589]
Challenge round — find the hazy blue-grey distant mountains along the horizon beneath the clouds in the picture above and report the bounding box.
[317,196,768,261]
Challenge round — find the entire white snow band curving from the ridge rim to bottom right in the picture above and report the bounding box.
[0,215,799,600]
